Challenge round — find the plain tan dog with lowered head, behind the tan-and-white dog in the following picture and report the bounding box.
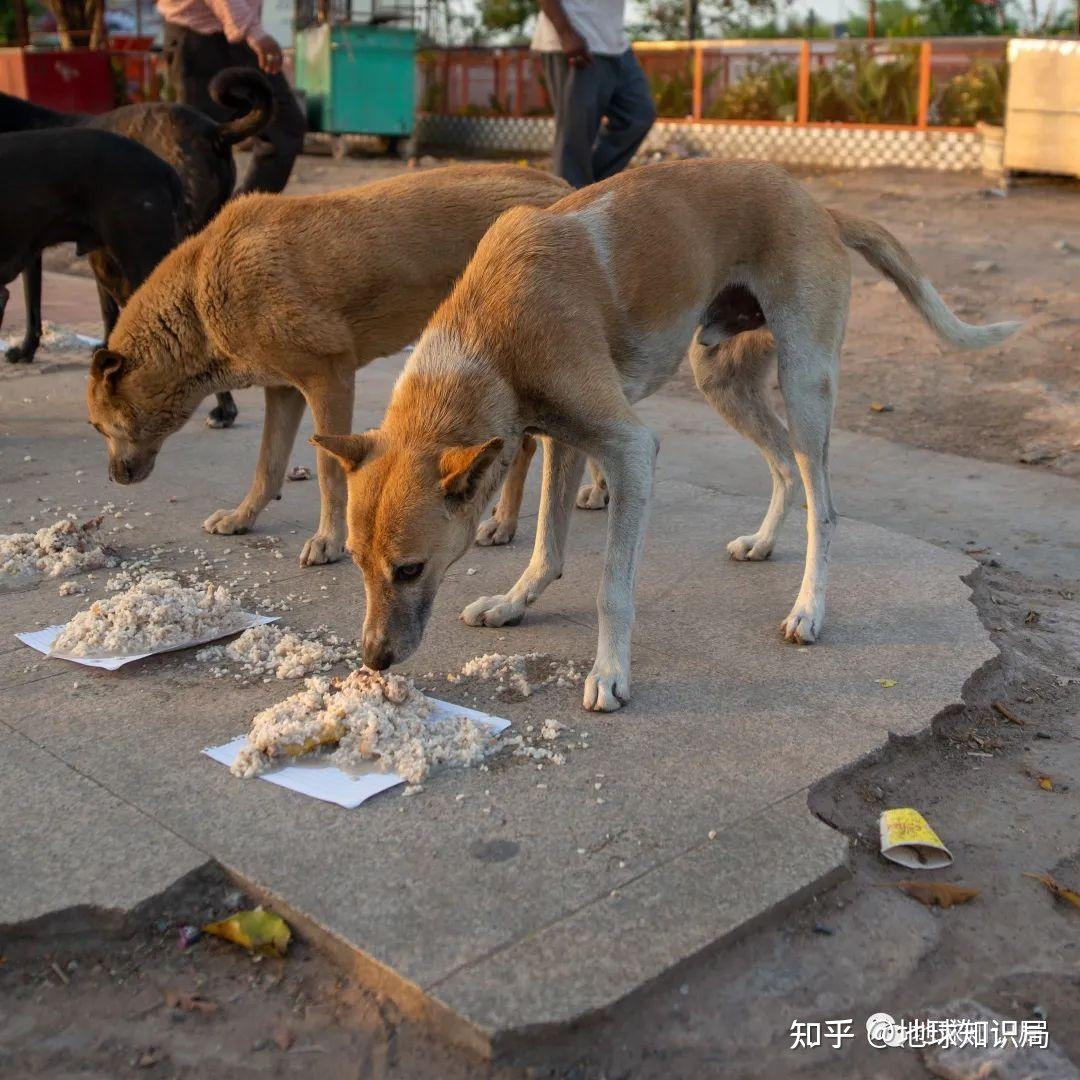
[87,165,570,566]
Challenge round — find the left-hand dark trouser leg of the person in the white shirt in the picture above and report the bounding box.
[540,53,611,188]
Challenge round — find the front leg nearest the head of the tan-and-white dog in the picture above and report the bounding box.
[461,437,584,626]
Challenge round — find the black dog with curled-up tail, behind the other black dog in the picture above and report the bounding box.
[0,68,274,428]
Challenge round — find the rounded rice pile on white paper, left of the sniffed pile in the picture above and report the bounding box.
[51,573,246,657]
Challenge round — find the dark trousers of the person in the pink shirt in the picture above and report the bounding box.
[165,25,307,193]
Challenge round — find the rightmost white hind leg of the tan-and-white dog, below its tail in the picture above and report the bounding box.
[779,332,842,645]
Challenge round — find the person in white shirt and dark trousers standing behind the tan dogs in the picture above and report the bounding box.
[532,0,657,188]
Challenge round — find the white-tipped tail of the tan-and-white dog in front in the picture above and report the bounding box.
[828,210,1024,349]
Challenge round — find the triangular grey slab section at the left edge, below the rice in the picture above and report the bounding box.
[0,725,207,932]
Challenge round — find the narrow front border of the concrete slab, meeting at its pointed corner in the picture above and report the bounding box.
[225,792,849,1061]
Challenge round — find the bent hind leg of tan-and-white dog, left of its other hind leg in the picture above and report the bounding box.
[690,329,797,562]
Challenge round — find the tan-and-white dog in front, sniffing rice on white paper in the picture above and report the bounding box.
[315,161,1018,711]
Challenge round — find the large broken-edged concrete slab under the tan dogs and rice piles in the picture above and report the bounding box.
[0,315,1006,1052]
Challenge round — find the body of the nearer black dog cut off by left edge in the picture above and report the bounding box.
[0,129,189,336]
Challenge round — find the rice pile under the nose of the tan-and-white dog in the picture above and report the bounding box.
[231,669,495,784]
